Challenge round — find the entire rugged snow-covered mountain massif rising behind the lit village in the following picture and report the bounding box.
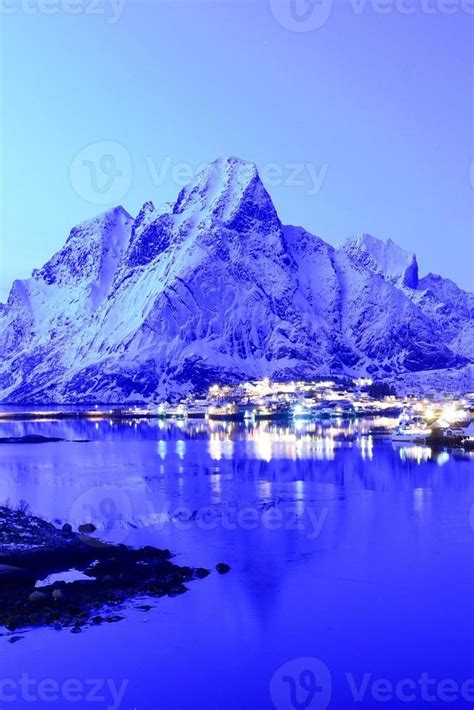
[0,158,474,402]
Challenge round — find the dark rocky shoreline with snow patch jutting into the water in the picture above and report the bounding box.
[0,506,230,642]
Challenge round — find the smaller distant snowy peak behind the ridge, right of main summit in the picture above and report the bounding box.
[342,233,418,289]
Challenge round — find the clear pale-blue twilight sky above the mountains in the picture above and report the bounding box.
[0,0,474,300]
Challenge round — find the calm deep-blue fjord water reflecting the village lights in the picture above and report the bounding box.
[0,420,474,710]
